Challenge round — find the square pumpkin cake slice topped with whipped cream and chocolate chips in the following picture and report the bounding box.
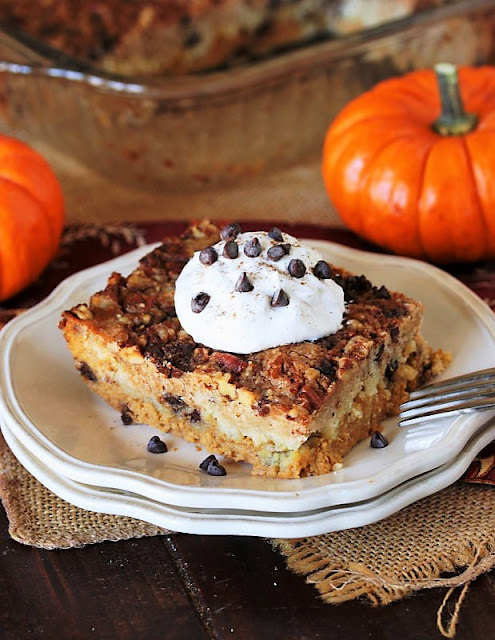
[60,221,447,478]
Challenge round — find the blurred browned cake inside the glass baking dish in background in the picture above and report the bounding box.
[0,0,449,75]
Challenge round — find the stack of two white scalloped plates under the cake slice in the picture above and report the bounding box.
[0,241,495,537]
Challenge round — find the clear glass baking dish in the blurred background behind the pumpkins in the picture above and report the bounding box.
[0,0,495,191]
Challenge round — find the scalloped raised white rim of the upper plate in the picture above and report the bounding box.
[0,240,495,511]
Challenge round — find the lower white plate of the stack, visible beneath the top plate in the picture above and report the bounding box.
[2,419,495,538]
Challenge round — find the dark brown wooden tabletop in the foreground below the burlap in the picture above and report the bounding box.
[0,225,495,640]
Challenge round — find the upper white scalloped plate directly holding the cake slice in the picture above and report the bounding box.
[0,241,495,513]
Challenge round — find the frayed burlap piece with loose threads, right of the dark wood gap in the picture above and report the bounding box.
[273,484,495,638]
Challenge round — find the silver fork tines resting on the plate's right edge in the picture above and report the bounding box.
[399,368,495,427]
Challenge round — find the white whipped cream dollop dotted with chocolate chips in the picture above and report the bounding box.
[175,225,345,354]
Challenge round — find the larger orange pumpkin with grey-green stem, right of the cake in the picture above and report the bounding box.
[322,64,495,263]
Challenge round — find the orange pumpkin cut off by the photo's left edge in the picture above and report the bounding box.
[0,135,64,300]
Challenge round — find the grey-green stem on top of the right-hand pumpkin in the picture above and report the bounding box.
[432,62,478,136]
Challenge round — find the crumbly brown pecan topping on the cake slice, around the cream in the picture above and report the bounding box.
[60,223,418,419]
